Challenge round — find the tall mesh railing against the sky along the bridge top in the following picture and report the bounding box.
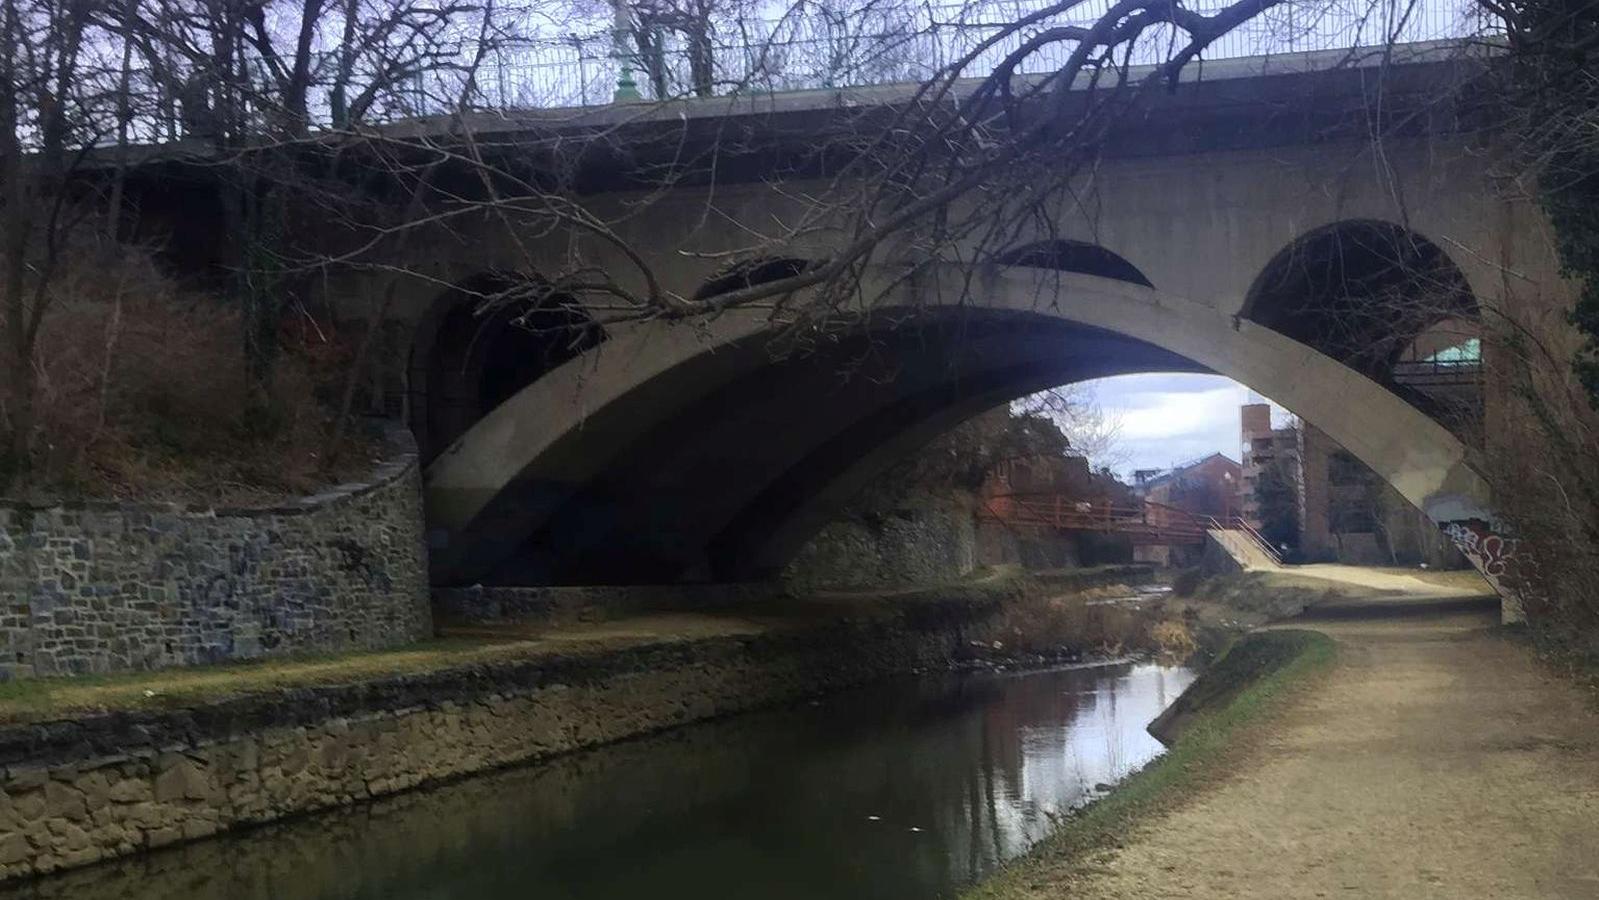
[466,0,1493,109]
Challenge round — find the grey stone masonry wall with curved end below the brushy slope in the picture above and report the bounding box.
[0,433,432,681]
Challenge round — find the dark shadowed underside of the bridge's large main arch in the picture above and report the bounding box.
[489,321,1202,583]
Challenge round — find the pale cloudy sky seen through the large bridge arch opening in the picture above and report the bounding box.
[1084,374,1286,481]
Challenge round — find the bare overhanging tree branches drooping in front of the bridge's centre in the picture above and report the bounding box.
[324,0,1298,334]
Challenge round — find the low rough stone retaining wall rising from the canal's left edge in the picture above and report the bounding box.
[0,588,1011,879]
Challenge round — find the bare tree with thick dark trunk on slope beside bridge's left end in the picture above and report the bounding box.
[110,0,530,385]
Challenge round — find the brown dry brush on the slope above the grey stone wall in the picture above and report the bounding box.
[7,243,371,504]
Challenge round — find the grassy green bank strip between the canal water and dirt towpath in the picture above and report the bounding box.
[961,630,1337,900]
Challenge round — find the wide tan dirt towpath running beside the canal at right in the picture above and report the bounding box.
[1061,596,1599,900]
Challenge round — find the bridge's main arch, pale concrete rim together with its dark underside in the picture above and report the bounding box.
[427,270,1484,583]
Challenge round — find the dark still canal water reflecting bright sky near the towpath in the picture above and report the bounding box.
[0,663,1193,900]
